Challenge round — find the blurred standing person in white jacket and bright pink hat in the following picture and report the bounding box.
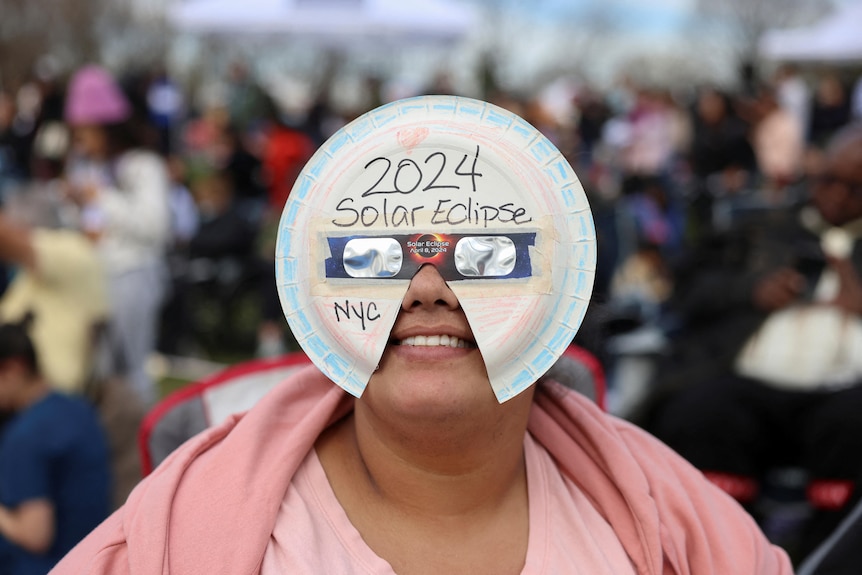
[65,65,171,404]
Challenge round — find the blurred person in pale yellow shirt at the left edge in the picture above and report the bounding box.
[0,191,143,506]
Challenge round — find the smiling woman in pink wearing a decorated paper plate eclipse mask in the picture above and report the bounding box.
[47,96,791,575]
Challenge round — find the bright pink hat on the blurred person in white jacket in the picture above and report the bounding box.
[65,65,132,126]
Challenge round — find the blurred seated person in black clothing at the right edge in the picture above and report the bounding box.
[646,126,862,557]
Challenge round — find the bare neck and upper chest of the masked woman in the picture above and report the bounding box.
[316,398,530,575]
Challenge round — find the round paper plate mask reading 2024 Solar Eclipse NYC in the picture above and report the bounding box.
[276,96,596,403]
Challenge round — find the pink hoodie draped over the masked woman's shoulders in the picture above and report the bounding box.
[51,367,792,575]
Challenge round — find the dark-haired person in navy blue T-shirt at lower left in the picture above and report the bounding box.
[0,324,111,575]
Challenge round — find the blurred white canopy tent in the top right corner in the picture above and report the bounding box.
[759,1,862,63]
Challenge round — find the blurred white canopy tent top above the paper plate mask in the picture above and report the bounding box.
[168,0,476,48]
